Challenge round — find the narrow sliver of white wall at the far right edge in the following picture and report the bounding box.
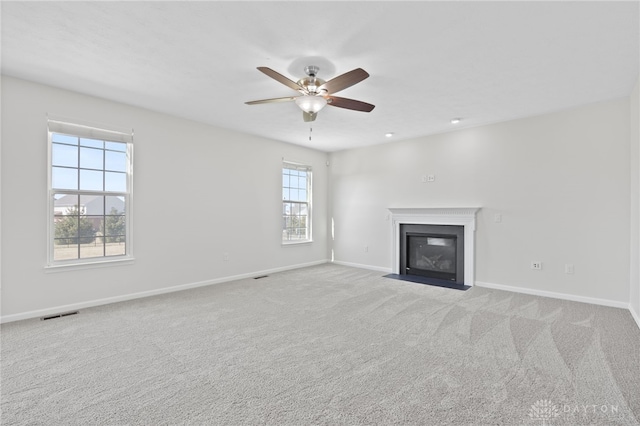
[629,78,640,326]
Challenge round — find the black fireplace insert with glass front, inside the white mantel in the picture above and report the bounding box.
[400,224,464,284]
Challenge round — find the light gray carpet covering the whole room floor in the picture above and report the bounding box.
[1,264,640,425]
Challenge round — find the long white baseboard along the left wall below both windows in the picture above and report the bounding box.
[0,259,329,323]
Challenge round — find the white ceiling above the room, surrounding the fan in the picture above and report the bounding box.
[1,1,640,151]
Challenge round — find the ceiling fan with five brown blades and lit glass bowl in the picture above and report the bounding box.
[245,65,375,121]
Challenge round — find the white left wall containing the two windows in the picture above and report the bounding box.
[1,77,328,320]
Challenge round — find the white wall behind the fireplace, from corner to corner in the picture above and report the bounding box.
[330,98,630,306]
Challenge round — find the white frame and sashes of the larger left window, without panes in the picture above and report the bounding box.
[45,115,134,272]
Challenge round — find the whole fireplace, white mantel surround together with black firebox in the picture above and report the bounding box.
[389,207,480,286]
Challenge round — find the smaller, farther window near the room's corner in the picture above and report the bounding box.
[282,162,311,243]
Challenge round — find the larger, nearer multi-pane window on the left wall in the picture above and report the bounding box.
[48,120,133,266]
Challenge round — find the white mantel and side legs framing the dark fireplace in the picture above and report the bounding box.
[389,207,480,286]
